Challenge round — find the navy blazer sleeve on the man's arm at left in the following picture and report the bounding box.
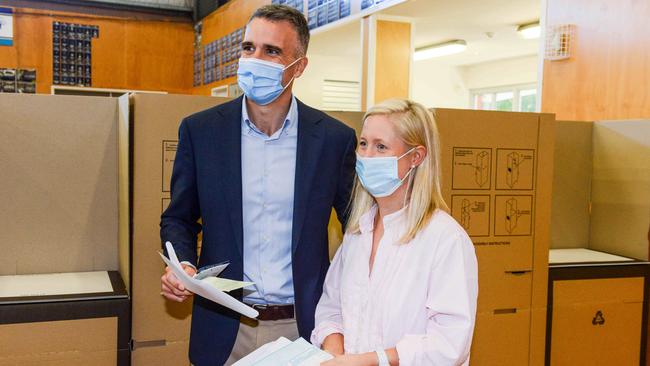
[160,120,201,266]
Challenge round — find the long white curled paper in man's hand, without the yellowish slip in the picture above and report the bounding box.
[158,242,259,318]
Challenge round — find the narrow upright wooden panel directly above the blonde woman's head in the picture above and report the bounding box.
[375,20,411,103]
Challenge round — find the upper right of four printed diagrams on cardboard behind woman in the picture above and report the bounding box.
[496,149,535,190]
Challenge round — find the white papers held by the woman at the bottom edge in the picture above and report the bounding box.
[233,337,332,366]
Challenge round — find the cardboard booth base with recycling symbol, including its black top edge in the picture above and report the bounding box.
[546,262,650,366]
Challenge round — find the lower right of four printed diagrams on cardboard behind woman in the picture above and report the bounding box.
[494,195,533,236]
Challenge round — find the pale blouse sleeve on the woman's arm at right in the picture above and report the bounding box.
[396,232,478,366]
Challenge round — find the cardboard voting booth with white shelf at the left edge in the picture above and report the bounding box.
[0,95,130,365]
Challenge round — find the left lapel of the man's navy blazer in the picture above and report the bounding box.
[213,97,244,258]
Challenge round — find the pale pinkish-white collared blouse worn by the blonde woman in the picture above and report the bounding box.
[311,206,478,366]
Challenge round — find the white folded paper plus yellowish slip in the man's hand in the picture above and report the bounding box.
[158,242,259,318]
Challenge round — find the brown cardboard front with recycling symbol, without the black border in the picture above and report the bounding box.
[550,277,644,366]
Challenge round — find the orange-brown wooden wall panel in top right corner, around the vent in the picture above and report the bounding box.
[542,0,650,121]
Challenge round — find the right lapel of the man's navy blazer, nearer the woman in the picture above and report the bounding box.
[291,101,324,255]
